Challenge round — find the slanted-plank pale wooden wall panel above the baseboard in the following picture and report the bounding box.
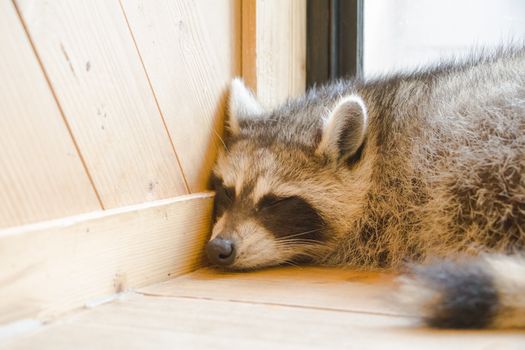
[0,0,240,227]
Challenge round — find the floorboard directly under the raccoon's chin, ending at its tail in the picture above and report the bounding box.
[139,267,400,316]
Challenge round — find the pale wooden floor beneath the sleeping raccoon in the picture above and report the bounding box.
[0,267,525,350]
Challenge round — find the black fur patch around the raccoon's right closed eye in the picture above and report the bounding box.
[255,194,325,243]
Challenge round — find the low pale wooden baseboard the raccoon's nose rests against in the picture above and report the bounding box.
[0,193,213,324]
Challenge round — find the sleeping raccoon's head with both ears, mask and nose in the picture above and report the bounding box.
[206,80,367,270]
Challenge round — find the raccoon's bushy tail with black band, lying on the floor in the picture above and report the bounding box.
[398,255,525,329]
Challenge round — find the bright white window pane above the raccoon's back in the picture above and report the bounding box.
[363,0,525,77]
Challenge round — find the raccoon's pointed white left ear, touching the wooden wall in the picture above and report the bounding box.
[228,78,264,135]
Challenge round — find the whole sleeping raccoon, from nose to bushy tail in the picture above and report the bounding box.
[206,49,525,328]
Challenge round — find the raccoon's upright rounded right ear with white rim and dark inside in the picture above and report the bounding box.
[316,95,368,161]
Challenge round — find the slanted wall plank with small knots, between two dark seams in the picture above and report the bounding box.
[16,0,190,208]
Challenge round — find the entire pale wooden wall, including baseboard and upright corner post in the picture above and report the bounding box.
[0,0,306,325]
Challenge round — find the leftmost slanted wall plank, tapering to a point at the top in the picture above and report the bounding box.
[0,1,100,228]
